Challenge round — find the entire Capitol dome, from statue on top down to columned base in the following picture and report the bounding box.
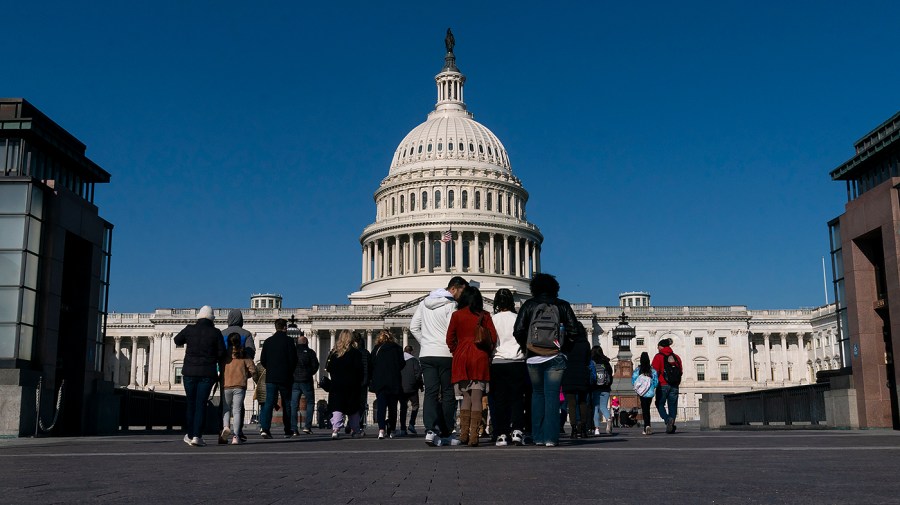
[349,30,543,304]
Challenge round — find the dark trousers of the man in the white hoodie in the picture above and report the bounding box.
[419,356,456,437]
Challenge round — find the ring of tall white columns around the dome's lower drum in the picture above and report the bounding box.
[362,226,541,284]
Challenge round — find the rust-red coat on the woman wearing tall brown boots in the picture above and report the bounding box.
[447,308,497,384]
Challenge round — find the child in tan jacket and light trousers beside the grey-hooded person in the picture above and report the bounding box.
[219,332,256,445]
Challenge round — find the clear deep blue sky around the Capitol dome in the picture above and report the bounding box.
[0,1,900,312]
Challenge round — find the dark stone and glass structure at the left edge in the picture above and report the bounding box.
[0,98,115,436]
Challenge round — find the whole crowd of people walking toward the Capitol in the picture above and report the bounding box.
[175,273,681,447]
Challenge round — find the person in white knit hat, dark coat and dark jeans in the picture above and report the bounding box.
[173,305,225,447]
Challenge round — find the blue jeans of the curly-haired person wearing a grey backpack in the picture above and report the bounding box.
[528,354,566,444]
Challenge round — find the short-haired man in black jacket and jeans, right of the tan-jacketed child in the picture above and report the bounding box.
[259,318,297,439]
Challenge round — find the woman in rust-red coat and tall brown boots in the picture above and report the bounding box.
[447,286,497,447]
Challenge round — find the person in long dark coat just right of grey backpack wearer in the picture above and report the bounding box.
[562,322,591,438]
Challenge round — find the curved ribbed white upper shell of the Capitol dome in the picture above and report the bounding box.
[390,111,511,174]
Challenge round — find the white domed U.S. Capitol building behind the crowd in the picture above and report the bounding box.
[104,36,841,419]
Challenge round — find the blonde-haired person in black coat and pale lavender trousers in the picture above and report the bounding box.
[325,330,364,439]
